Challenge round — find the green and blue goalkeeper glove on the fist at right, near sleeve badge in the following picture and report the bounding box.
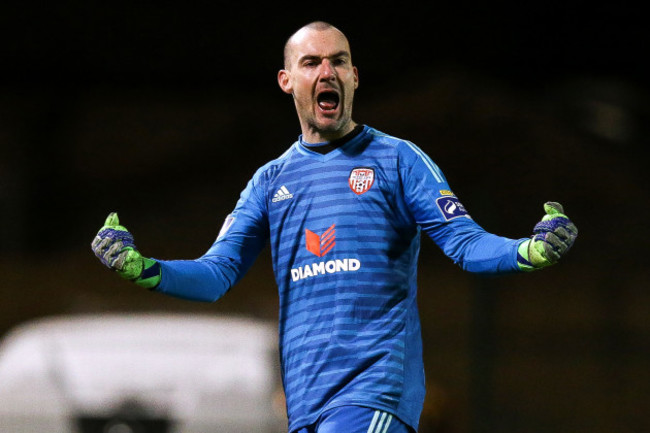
[517,202,578,271]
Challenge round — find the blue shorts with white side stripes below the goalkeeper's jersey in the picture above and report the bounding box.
[294,406,414,433]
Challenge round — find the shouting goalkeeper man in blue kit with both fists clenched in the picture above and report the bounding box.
[92,22,577,433]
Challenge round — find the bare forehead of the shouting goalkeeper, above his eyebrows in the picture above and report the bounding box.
[289,29,350,63]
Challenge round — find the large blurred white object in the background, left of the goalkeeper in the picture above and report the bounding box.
[0,313,287,433]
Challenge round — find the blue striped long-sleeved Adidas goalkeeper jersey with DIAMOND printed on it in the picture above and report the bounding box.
[157,126,522,431]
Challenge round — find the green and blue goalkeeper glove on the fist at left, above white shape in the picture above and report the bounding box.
[91,212,161,289]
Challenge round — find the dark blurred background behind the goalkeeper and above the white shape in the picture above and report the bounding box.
[0,1,650,433]
